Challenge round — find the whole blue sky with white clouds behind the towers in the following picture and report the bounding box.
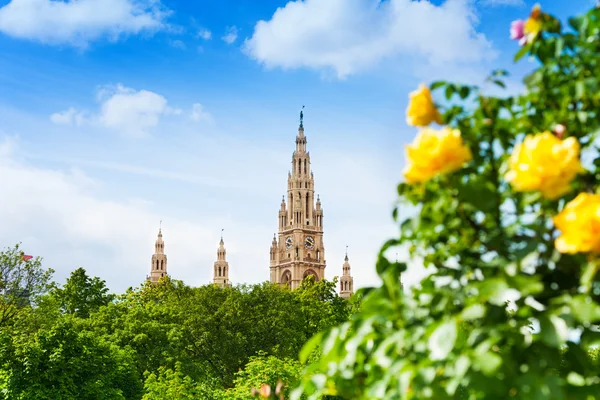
[0,0,593,291]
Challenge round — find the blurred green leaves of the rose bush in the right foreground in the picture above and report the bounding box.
[292,8,600,400]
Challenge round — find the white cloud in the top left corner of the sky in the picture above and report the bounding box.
[0,0,169,47]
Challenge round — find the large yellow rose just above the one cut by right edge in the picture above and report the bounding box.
[505,131,583,199]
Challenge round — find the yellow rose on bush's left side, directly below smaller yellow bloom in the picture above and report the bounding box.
[402,127,473,183]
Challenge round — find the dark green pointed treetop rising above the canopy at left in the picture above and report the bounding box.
[53,268,115,318]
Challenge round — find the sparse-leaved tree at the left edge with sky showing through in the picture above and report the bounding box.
[0,245,54,328]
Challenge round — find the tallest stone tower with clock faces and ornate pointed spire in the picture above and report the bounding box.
[270,111,325,289]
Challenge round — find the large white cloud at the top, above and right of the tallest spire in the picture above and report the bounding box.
[244,0,495,78]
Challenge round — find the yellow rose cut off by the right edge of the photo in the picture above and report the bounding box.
[554,193,600,254]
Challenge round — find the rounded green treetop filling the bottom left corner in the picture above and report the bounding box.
[2,316,142,400]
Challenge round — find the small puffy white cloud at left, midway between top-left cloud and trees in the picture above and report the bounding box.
[50,84,212,137]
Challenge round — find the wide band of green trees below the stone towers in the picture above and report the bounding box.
[0,253,351,400]
